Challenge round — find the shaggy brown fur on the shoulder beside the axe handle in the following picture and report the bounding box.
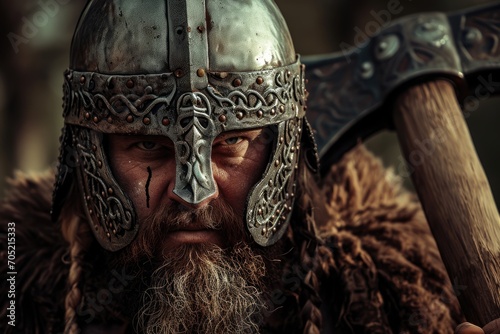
[319,146,461,333]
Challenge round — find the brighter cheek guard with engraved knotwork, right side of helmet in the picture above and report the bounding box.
[248,119,302,243]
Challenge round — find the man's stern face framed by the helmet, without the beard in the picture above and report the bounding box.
[108,129,270,254]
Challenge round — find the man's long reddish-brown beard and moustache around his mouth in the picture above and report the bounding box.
[109,200,283,333]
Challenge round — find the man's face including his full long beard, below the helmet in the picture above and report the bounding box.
[108,129,281,333]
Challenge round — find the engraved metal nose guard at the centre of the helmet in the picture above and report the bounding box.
[174,92,216,203]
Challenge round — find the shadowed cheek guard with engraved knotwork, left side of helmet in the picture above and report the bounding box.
[73,128,133,239]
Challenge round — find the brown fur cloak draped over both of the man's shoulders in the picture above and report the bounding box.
[0,147,462,333]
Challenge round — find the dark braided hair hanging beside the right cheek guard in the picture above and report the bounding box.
[264,149,333,334]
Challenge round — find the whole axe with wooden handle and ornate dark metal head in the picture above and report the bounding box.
[304,4,500,326]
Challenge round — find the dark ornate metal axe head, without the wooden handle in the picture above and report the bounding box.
[303,4,500,173]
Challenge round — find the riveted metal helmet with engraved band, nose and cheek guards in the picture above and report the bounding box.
[53,0,316,251]
